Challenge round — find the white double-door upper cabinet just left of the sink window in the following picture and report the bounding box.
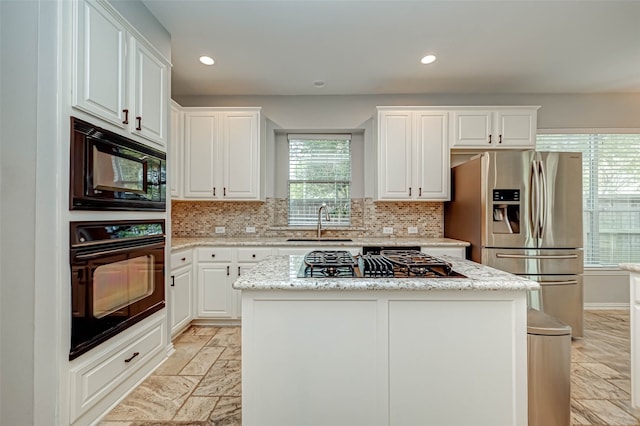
[183,108,262,200]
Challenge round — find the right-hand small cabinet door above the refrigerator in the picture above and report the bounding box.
[496,110,537,148]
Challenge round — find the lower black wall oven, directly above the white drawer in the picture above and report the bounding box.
[69,220,165,360]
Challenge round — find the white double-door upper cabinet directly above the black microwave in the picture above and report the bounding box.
[72,0,169,148]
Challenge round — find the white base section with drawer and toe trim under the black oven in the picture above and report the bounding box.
[69,309,167,425]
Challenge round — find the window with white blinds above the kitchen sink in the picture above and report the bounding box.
[288,134,351,226]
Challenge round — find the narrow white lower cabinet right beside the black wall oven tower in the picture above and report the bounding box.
[168,250,193,336]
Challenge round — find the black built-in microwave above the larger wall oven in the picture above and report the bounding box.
[69,117,167,211]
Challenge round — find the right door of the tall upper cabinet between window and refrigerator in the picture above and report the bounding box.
[413,111,450,200]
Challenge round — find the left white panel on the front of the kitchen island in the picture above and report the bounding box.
[242,298,385,426]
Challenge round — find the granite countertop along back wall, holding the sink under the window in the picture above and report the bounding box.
[171,237,469,250]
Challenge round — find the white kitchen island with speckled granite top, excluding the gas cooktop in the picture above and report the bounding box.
[234,256,538,426]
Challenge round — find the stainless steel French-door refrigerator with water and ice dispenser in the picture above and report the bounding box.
[444,151,584,337]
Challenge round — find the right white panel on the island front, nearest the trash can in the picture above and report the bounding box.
[389,300,520,426]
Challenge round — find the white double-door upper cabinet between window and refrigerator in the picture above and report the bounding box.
[377,107,450,201]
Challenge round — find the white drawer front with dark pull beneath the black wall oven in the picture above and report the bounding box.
[70,315,166,422]
